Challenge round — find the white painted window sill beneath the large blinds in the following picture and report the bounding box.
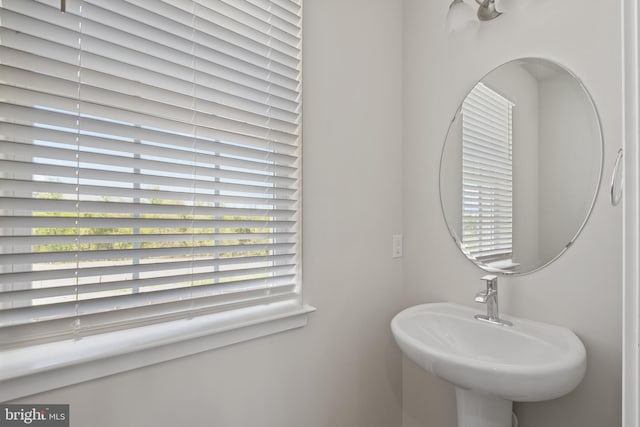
[0,302,315,402]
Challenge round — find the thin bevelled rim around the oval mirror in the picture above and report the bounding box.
[438,56,605,277]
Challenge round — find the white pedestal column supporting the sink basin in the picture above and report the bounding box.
[456,387,513,427]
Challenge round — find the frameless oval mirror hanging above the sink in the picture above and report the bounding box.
[440,58,603,274]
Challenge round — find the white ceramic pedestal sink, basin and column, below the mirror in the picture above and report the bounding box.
[391,303,587,427]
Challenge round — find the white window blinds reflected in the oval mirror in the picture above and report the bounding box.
[462,83,514,262]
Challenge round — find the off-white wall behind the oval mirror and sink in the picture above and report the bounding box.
[403,0,621,427]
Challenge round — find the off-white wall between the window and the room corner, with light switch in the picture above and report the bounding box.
[21,0,402,427]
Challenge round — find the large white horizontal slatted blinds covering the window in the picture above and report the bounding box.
[0,0,301,346]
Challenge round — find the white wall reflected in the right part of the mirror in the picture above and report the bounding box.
[539,74,607,259]
